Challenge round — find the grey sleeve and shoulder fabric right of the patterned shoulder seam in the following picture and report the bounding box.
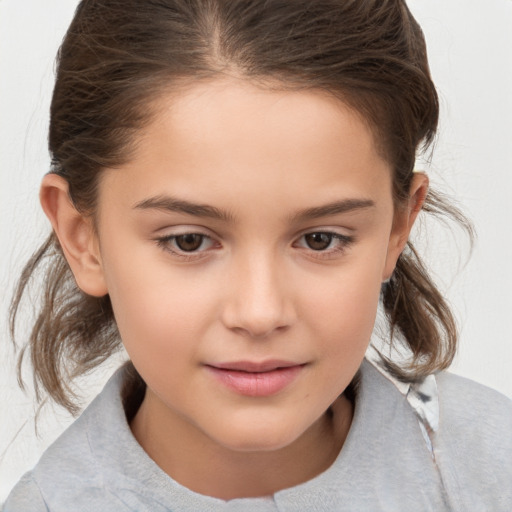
[434,372,512,512]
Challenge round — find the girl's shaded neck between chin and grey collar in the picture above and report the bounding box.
[131,390,353,500]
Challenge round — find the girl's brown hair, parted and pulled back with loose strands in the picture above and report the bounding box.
[10,0,471,412]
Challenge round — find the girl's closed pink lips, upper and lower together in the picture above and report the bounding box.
[206,360,305,397]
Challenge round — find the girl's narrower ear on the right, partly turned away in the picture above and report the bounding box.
[382,172,428,281]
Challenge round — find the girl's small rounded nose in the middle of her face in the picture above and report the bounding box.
[223,250,296,339]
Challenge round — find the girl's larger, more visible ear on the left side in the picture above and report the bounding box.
[39,174,107,297]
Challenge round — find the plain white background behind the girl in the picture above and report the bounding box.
[0,0,512,502]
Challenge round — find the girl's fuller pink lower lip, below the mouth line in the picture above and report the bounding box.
[207,365,304,396]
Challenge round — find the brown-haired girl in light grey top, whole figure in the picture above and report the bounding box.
[5,0,512,511]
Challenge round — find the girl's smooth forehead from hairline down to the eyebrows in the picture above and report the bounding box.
[100,79,390,216]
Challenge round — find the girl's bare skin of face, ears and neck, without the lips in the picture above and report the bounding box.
[41,79,428,499]
